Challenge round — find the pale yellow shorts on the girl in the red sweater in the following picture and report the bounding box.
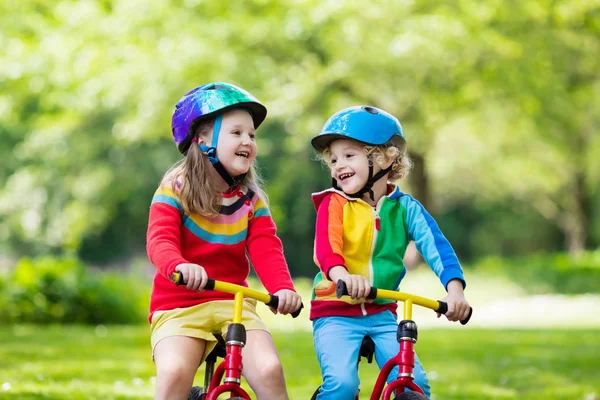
[150,299,268,362]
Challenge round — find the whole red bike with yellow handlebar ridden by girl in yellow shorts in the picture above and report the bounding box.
[171,272,304,400]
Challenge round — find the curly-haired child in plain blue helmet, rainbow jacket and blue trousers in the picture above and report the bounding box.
[310,106,470,400]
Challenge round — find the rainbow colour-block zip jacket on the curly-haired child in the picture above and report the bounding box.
[310,185,465,319]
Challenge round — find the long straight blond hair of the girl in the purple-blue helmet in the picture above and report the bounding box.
[161,118,267,217]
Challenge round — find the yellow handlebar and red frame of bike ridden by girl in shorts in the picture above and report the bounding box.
[171,272,302,400]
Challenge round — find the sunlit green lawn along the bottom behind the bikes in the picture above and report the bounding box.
[0,326,600,400]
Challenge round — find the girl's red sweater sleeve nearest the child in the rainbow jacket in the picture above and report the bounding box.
[246,200,294,293]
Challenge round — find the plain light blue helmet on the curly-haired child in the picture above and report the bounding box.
[310,106,406,152]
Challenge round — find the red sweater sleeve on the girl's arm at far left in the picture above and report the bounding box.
[146,195,188,280]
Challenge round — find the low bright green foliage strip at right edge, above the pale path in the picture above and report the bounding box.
[474,249,600,294]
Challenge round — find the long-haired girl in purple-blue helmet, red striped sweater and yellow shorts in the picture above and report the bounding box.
[146,82,301,400]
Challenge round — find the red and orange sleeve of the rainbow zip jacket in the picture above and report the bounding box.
[315,193,347,278]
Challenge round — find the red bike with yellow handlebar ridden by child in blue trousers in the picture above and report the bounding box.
[311,280,473,400]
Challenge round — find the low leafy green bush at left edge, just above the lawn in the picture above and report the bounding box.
[0,256,150,324]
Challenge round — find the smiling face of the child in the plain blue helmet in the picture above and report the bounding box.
[329,139,369,194]
